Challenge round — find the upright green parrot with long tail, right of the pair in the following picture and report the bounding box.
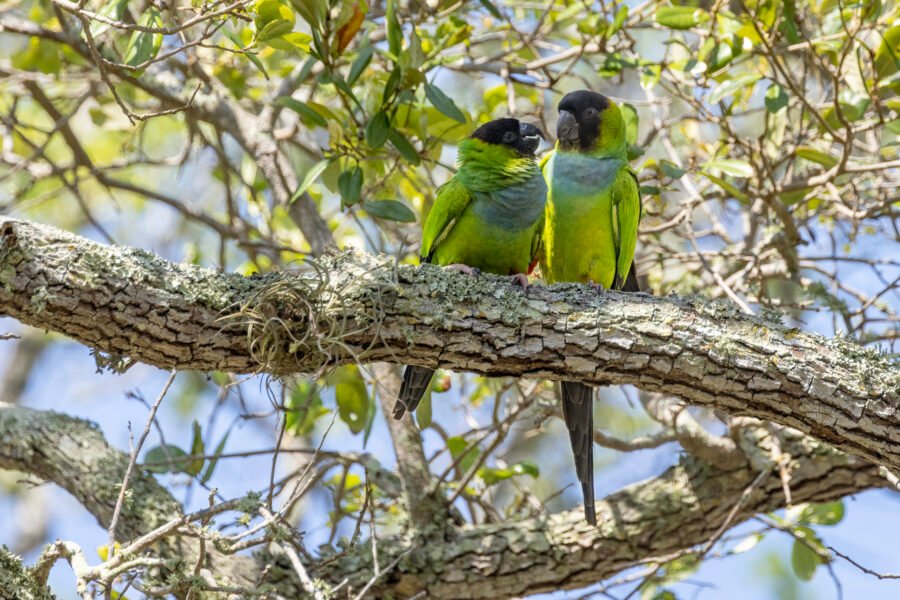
[540,90,641,525]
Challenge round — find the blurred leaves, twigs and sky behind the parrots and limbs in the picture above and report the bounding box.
[0,0,900,598]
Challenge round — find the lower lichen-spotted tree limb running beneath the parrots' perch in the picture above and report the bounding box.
[0,406,888,599]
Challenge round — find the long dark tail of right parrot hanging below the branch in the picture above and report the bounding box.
[562,381,597,525]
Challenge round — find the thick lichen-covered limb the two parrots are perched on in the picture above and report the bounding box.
[0,219,900,471]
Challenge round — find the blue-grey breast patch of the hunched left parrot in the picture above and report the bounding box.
[472,170,547,230]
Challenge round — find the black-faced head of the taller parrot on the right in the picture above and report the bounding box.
[556,90,625,152]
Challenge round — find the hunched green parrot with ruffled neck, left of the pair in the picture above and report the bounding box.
[394,119,547,419]
